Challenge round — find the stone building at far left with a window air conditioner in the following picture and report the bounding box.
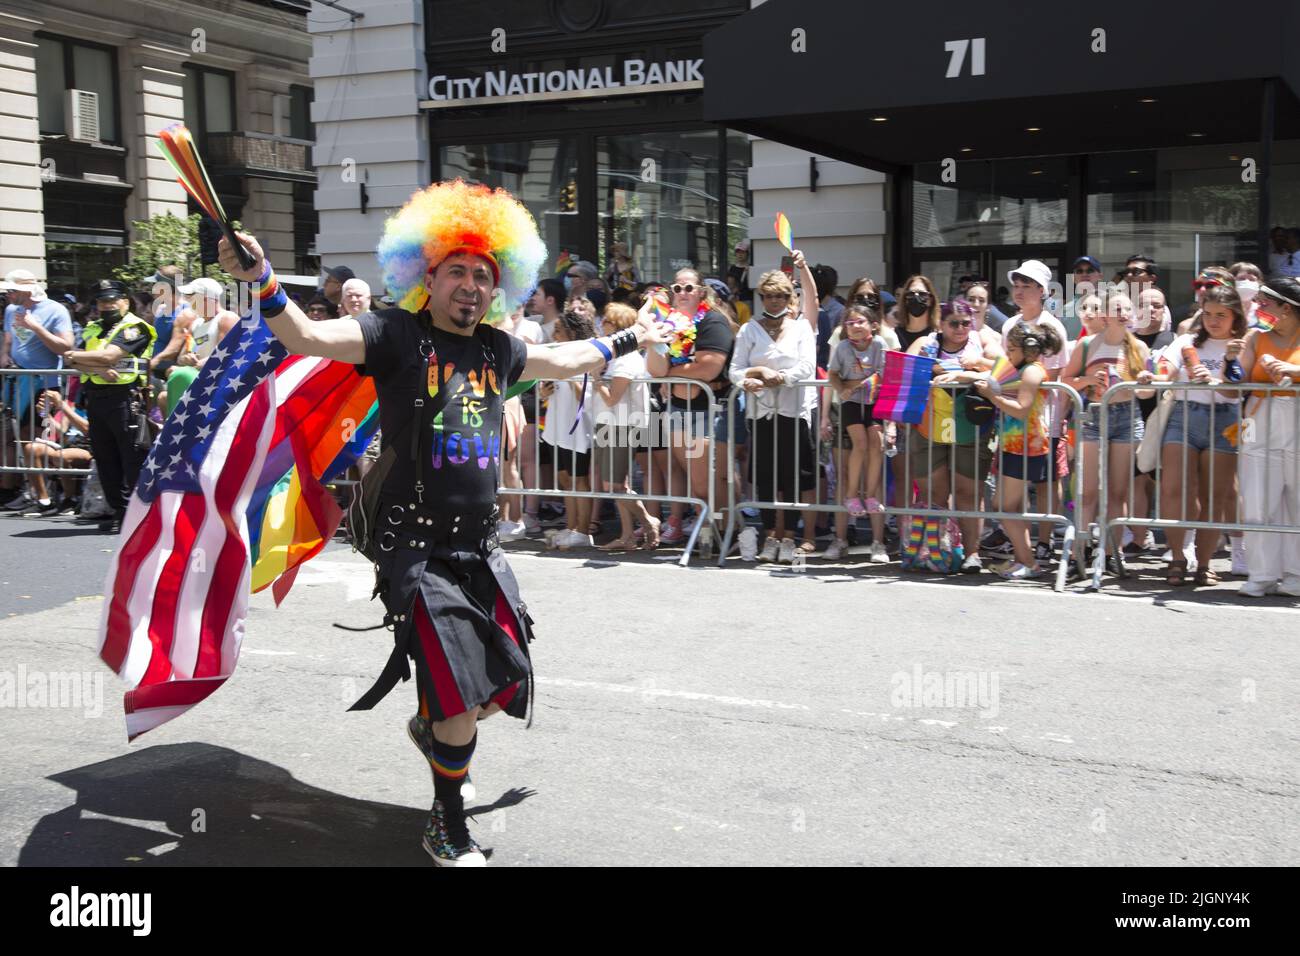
[0,0,317,294]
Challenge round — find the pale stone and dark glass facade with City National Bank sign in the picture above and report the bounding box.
[311,0,885,297]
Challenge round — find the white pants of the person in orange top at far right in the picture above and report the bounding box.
[1238,398,1300,584]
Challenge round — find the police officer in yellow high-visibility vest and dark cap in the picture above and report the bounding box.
[64,278,157,535]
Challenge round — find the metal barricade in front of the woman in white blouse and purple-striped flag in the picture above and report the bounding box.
[719,380,1084,591]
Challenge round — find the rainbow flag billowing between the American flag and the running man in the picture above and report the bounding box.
[247,355,380,606]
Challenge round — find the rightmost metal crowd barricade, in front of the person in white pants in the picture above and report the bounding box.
[1089,381,1300,589]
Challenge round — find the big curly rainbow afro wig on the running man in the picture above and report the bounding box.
[376,179,546,321]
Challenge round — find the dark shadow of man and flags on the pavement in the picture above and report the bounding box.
[18,744,530,866]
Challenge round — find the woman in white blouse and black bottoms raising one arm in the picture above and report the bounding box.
[729,265,818,562]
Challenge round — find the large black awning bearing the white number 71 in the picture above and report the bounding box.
[703,0,1300,169]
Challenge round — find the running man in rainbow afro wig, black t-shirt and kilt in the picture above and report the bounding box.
[221,179,664,866]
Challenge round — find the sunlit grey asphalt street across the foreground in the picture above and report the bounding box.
[0,518,1300,866]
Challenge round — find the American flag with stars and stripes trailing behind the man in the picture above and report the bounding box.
[99,317,287,739]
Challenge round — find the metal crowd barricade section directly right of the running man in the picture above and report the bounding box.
[498,376,729,567]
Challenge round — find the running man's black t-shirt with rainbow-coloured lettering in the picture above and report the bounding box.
[356,308,528,510]
